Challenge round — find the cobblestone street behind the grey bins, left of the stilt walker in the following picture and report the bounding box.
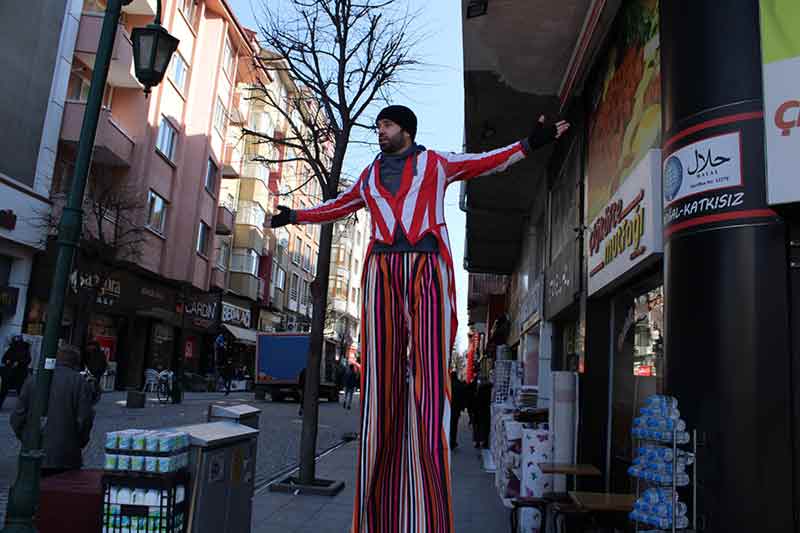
[0,393,358,524]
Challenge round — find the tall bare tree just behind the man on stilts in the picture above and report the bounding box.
[244,0,420,484]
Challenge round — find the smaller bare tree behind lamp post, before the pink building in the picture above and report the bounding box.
[38,165,147,349]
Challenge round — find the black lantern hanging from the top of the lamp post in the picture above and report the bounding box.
[131,0,179,97]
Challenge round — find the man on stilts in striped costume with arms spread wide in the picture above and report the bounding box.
[270,105,569,533]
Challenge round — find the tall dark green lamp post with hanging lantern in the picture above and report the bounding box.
[3,0,178,533]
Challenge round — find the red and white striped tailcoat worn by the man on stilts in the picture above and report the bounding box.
[295,142,527,345]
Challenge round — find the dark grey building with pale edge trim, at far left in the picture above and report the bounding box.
[0,0,82,360]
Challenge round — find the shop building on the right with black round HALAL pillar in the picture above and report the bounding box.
[462,0,800,531]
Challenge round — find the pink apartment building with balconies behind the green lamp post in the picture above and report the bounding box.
[25,0,255,387]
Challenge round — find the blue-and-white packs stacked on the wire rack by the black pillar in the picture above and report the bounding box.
[628,395,694,533]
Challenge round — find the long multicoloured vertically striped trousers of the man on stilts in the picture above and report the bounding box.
[352,253,453,533]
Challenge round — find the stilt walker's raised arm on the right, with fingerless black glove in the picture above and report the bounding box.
[440,116,569,184]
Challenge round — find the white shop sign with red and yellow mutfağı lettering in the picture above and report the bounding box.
[587,150,663,294]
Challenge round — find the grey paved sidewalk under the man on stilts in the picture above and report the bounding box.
[253,441,508,533]
